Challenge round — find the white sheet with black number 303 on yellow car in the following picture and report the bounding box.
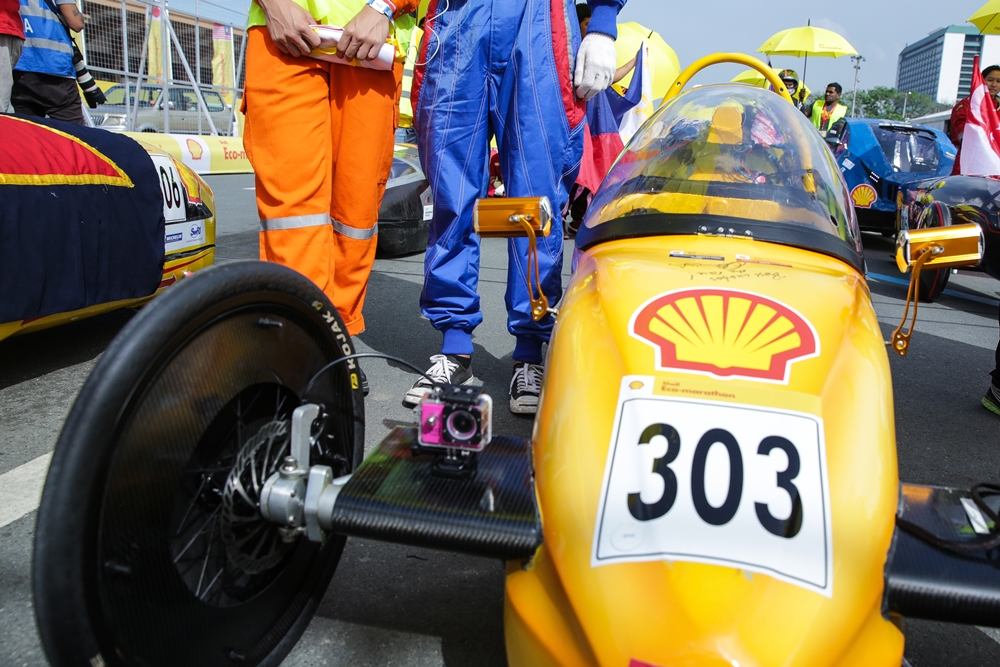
[591,376,833,596]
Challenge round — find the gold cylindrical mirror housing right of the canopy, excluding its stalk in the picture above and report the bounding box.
[896,223,986,273]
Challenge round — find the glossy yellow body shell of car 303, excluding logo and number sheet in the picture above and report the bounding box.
[505,236,903,667]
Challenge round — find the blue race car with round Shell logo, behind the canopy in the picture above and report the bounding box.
[826,118,956,236]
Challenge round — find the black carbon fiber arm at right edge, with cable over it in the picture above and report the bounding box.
[885,484,1000,627]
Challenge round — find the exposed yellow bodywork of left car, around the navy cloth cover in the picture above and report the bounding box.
[0,144,215,340]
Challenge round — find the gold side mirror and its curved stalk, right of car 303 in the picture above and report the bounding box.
[889,223,986,357]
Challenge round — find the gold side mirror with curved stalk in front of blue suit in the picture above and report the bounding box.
[472,197,554,322]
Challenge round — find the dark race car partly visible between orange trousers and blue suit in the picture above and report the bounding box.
[378,144,434,257]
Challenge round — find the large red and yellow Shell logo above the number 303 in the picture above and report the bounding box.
[629,289,819,384]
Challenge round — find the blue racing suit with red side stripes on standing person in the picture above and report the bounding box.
[412,0,625,363]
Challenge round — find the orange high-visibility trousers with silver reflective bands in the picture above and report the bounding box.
[243,27,402,335]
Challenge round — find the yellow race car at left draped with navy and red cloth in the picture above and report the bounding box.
[0,115,215,340]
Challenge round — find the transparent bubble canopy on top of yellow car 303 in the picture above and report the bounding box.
[577,84,864,271]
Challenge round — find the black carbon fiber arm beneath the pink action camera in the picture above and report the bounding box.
[331,428,542,560]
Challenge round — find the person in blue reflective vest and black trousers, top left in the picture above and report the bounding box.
[11,0,87,125]
